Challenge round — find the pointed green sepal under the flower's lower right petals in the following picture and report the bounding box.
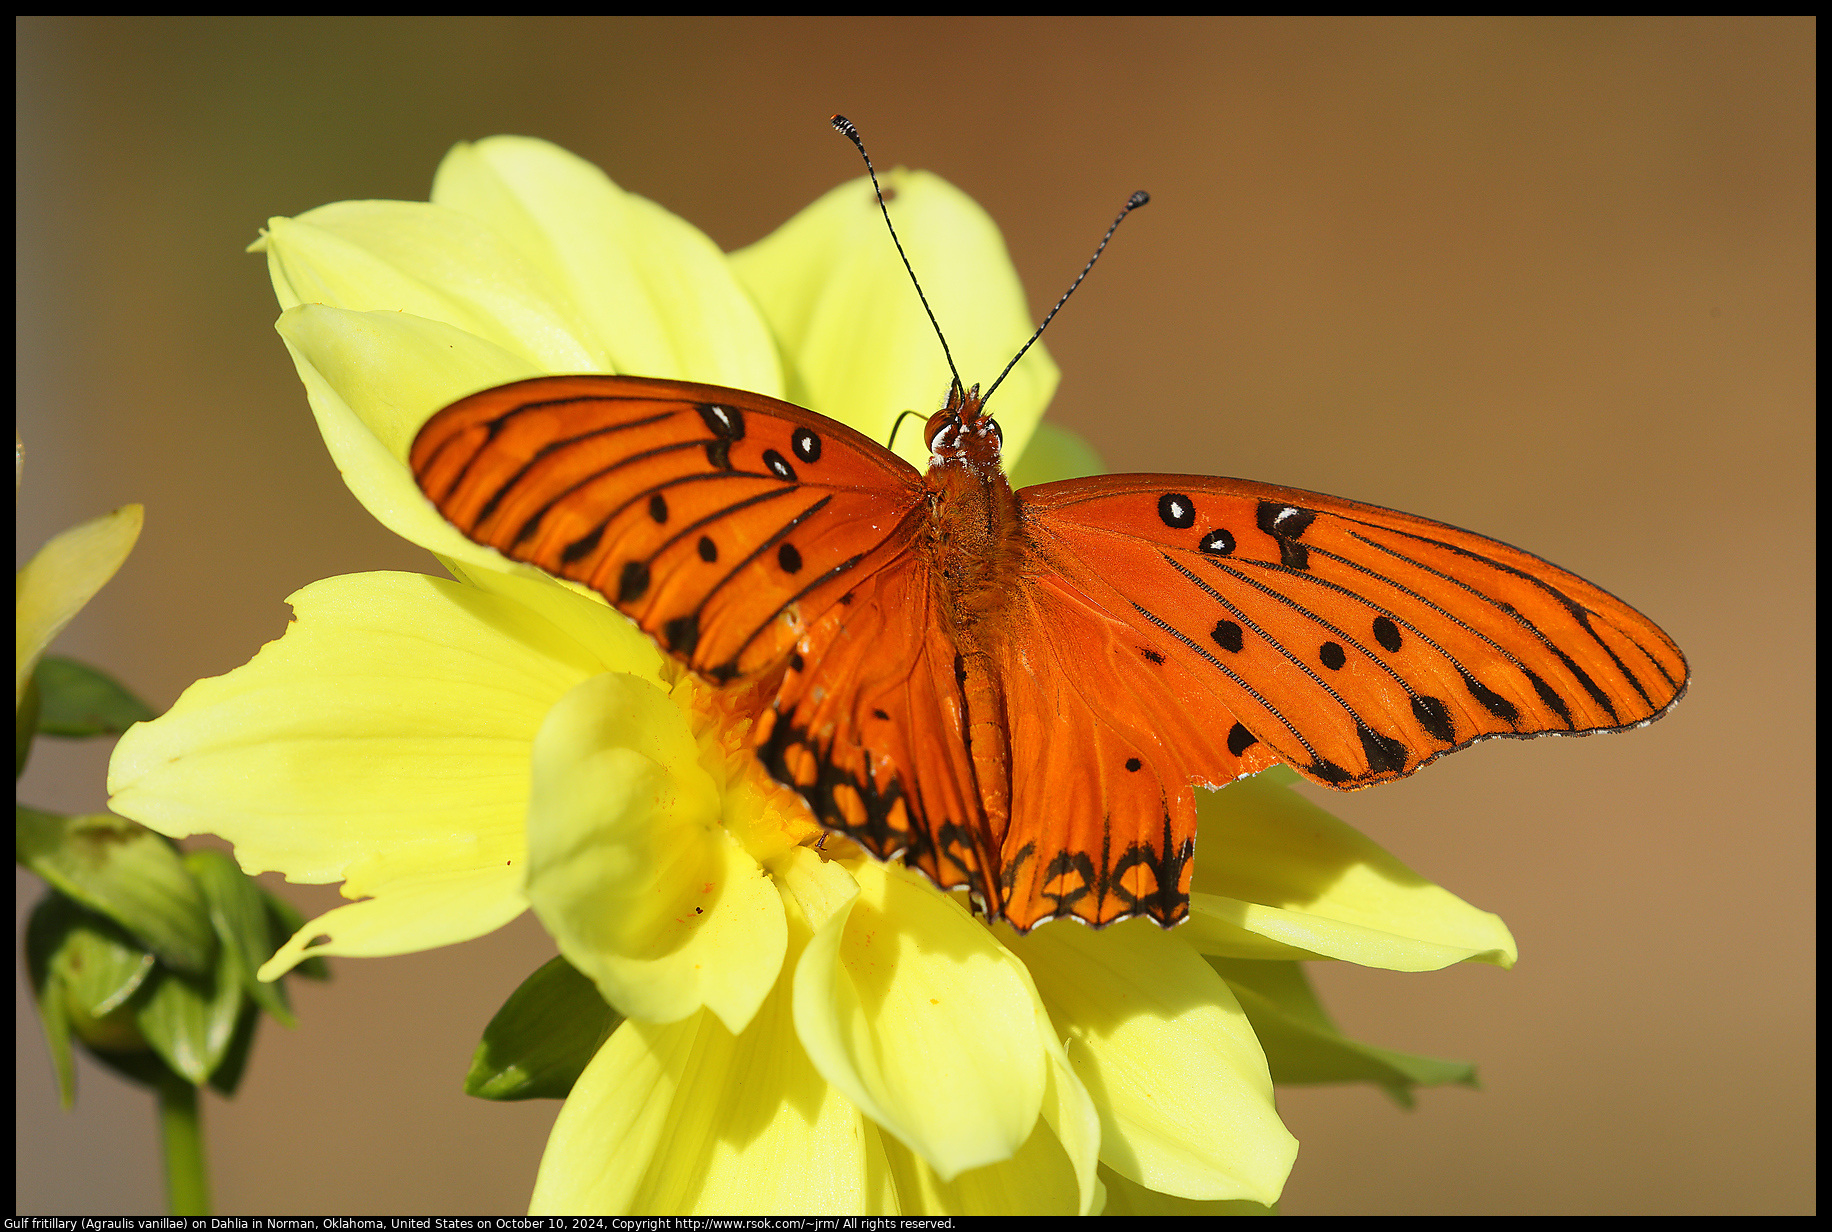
[1209,957,1478,1107]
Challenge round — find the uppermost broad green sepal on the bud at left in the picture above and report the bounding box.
[13,805,216,975]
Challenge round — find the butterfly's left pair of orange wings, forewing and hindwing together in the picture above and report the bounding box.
[410,376,995,900]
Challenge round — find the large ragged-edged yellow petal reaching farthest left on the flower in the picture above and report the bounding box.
[108,574,636,975]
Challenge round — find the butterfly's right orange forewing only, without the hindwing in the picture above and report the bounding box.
[1020,475,1685,787]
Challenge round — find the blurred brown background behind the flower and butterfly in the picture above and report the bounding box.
[16,20,1816,1216]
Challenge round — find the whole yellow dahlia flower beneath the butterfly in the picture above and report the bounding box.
[110,138,1513,1214]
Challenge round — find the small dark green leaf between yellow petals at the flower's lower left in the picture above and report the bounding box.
[463,959,623,1100]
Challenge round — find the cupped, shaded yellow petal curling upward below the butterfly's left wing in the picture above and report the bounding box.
[528,673,788,1032]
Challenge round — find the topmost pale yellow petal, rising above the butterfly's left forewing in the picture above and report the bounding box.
[432,138,782,398]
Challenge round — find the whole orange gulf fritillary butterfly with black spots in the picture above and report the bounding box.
[410,121,1687,931]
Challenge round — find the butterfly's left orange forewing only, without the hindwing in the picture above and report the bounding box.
[409,376,921,682]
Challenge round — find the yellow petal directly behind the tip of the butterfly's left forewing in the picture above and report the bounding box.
[275,304,540,570]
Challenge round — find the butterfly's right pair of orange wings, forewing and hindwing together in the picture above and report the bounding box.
[1000,475,1685,930]
